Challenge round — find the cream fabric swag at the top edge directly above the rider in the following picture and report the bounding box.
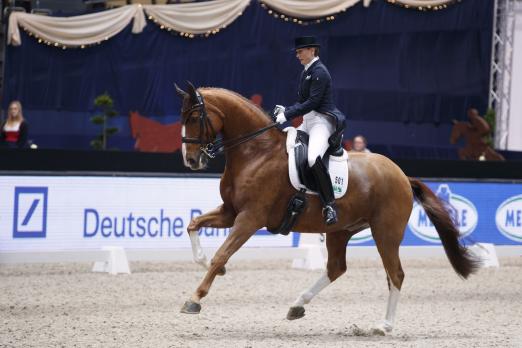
[260,0,370,18]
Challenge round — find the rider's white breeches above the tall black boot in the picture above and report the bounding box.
[297,111,335,167]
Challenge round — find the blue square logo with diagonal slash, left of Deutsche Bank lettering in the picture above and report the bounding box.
[13,187,48,238]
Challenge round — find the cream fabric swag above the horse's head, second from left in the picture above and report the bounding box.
[143,0,250,34]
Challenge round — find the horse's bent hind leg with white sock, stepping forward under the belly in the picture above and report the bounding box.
[286,231,351,320]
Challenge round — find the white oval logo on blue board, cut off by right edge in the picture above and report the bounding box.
[495,195,522,243]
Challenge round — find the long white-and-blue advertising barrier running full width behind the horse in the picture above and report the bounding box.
[0,176,522,251]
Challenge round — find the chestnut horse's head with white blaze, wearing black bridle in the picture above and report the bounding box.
[175,81,223,170]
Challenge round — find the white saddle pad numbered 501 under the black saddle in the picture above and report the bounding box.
[284,127,348,199]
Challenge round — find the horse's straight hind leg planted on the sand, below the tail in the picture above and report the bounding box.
[371,219,406,335]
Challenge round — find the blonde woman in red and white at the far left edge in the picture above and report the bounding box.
[0,100,28,149]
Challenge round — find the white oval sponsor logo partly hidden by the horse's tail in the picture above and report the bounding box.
[408,184,478,243]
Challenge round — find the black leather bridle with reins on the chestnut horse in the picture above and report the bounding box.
[181,90,277,158]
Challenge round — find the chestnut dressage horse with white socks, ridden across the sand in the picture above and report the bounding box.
[176,83,477,335]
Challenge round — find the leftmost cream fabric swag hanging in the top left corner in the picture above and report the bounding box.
[7,5,146,47]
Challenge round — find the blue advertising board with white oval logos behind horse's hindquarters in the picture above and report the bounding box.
[351,181,522,245]
